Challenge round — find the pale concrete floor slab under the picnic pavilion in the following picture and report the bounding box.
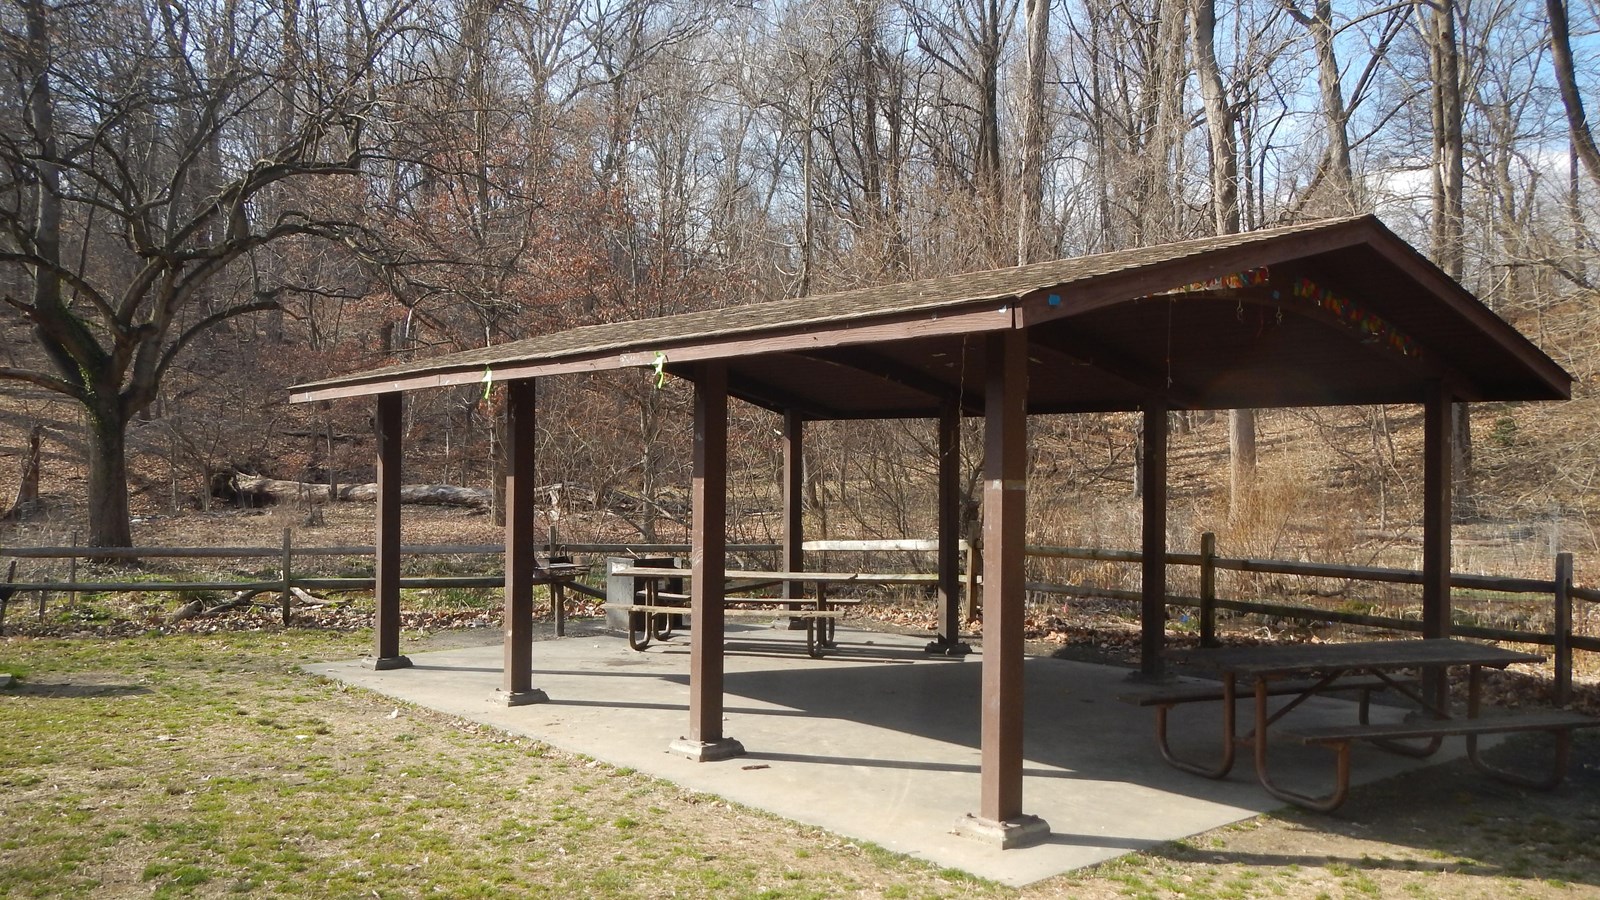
[306,626,1459,886]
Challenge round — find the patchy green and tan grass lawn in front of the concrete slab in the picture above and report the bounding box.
[0,631,1600,898]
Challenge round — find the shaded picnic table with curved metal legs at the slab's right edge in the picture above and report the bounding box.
[1123,639,1600,812]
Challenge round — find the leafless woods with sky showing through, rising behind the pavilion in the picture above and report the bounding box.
[0,0,1600,544]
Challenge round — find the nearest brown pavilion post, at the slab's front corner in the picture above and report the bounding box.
[957,330,1050,847]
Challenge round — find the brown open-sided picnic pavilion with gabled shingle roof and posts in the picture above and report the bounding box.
[291,216,1571,847]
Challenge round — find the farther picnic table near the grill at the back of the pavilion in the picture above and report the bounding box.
[611,565,938,658]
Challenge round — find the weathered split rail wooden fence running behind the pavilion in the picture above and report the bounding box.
[0,528,1600,703]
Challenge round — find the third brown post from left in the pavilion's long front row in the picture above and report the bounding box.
[670,360,744,762]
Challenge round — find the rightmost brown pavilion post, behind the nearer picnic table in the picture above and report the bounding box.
[1422,383,1454,705]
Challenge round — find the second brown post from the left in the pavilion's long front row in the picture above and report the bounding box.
[499,378,549,706]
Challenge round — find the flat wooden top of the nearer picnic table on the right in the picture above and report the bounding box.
[1166,637,1544,677]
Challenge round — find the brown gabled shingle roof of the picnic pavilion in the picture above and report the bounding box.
[291,216,1571,418]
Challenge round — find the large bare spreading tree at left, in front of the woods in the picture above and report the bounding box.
[0,0,403,546]
